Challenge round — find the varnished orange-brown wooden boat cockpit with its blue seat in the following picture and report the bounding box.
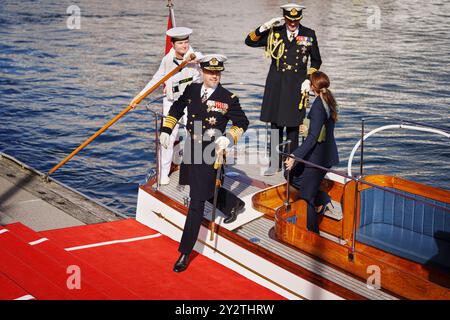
[275,176,450,299]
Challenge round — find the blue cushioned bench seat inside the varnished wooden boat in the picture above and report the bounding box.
[356,188,450,269]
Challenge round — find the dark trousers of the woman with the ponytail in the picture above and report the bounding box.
[290,164,330,233]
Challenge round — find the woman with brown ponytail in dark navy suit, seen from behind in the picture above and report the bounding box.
[285,71,339,233]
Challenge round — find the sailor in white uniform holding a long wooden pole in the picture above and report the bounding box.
[130,27,201,185]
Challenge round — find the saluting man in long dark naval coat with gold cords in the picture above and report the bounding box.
[245,3,322,175]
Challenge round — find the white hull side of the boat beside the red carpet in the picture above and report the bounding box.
[136,188,342,300]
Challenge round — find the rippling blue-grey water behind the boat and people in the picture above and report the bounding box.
[0,0,450,215]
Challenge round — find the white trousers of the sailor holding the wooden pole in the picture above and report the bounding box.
[159,98,187,177]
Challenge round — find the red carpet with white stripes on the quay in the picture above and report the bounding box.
[0,219,284,300]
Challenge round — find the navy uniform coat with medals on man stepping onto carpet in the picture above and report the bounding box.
[161,83,249,200]
